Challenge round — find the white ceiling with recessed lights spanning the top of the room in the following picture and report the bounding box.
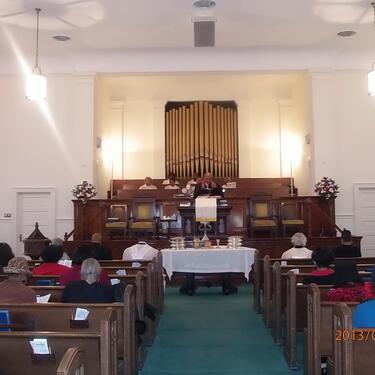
[0,0,375,72]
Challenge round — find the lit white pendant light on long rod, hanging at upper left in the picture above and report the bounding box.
[26,8,47,100]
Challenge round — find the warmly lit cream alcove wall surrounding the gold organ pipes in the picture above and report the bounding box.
[97,73,310,195]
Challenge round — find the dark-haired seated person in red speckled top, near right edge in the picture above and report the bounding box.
[325,261,372,302]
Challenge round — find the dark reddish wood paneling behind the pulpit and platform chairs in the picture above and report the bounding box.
[74,194,335,240]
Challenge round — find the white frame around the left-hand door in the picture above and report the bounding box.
[12,186,56,255]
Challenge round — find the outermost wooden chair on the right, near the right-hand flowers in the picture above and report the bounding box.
[280,201,305,236]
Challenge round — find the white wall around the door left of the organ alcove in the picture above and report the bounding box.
[0,75,94,254]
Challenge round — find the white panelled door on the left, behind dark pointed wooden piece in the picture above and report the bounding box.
[16,189,55,255]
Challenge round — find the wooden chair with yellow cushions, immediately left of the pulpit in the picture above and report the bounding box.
[129,198,159,238]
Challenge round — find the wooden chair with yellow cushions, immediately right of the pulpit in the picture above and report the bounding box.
[249,196,278,237]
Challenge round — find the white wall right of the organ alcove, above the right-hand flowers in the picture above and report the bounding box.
[311,71,375,254]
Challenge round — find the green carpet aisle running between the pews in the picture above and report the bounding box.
[140,287,302,375]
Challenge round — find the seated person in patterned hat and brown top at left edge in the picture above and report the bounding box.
[0,257,36,303]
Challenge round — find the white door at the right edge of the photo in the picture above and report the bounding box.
[354,184,375,256]
